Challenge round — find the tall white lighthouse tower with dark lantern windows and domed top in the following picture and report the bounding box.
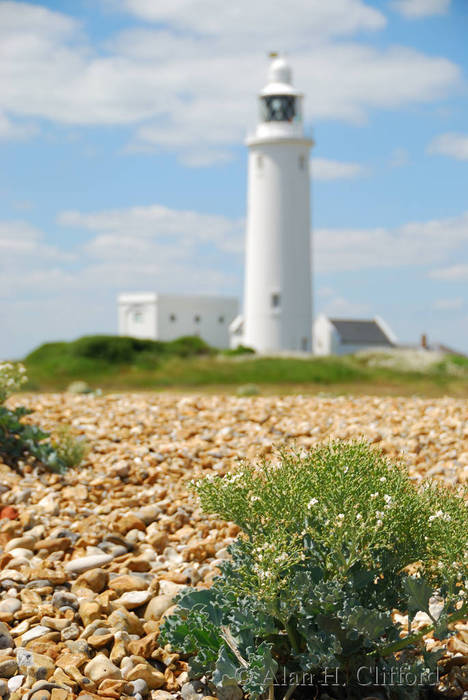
[239,54,313,353]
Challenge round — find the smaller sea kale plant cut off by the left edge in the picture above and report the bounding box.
[0,362,85,473]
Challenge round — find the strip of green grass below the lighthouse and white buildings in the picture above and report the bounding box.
[20,336,468,397]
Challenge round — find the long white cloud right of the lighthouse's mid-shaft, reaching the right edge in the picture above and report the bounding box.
[313,212,468,270]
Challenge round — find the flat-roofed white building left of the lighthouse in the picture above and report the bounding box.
[118,292,239,348]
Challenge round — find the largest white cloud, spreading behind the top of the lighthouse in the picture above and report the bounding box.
[0,0,461,165]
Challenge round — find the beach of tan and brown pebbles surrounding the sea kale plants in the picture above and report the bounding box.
[0,393,468,700]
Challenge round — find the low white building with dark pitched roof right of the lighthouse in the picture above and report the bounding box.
[313,314,397,355]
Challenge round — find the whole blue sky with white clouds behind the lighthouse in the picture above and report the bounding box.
[0,0,468,357]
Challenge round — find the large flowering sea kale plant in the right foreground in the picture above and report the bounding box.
[161,443,468,698]
